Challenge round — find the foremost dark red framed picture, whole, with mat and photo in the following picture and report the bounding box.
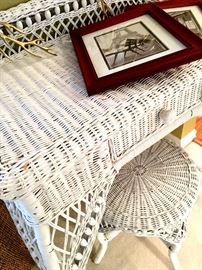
[70,4,202,95]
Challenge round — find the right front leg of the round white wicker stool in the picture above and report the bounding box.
[161,239,181,270]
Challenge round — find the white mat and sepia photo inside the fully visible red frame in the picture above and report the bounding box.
[82,14,185,78]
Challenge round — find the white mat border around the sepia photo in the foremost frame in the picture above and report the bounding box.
[82,14,186,78]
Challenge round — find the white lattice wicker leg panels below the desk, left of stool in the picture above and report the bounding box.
[7,173,114,270]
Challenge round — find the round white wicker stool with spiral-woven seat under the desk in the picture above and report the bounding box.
[94,140,199,269]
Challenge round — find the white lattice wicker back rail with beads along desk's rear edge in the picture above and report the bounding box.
[0,0,148,58]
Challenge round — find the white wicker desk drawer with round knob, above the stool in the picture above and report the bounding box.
[109,82,202,161]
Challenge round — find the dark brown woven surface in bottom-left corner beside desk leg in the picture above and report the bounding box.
[0,201,34,270]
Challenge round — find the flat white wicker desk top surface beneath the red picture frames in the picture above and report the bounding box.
[0,37,202,188]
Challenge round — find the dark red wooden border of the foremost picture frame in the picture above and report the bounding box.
[70,4,202,95]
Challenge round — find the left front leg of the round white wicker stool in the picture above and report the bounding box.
[93,231,121,264]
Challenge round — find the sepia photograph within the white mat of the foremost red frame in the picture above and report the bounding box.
[95,21,168,69]
